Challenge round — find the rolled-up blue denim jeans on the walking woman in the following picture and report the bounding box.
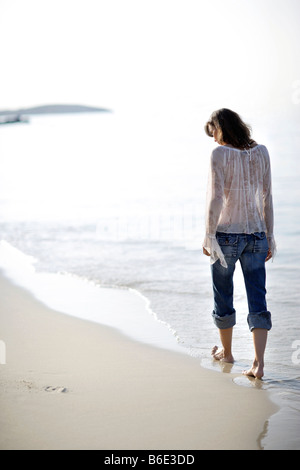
[211,232,272,331]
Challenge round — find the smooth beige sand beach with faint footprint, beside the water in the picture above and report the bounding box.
[0,276,275,450]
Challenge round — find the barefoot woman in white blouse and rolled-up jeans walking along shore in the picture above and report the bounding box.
[203,109,276,379]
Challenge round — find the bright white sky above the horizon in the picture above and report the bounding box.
[0,0,300,115]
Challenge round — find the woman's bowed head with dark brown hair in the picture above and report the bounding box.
[204,108,254,149]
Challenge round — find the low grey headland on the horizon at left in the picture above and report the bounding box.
[0,104,111,116]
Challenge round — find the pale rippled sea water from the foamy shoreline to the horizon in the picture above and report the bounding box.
[0,112,300,449]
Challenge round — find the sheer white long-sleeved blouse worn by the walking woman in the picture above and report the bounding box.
[203,145,276,267]
